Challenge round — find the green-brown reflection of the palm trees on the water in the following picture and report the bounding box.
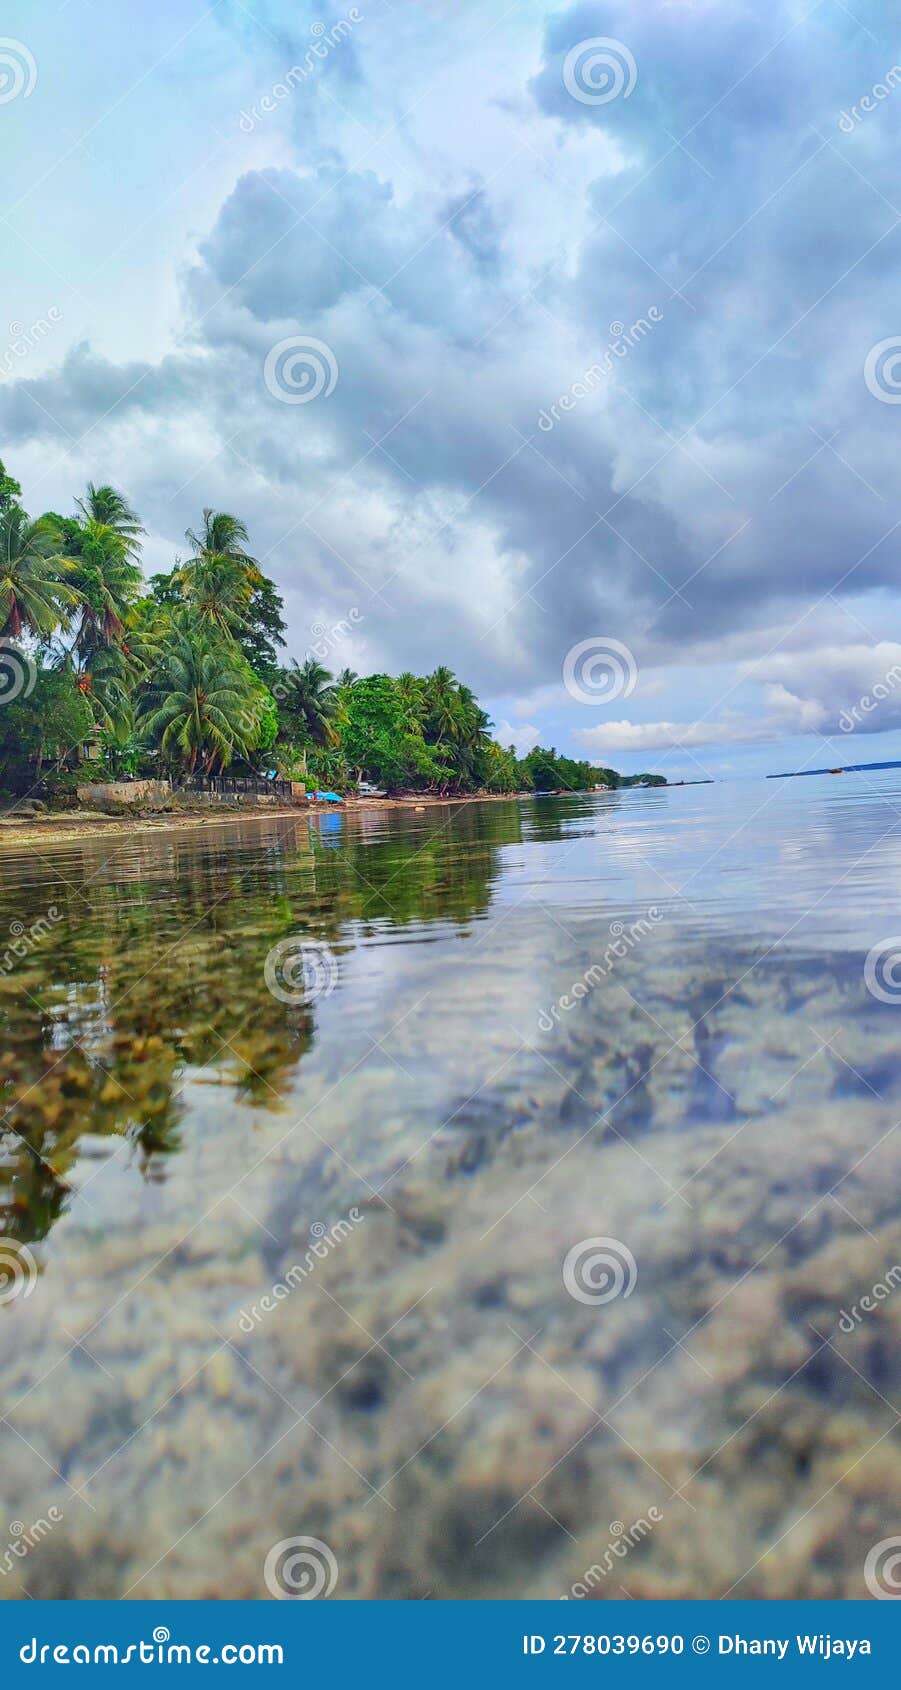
[0,804,521,1240]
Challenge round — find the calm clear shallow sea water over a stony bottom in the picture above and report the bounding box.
[0,771,901,1599]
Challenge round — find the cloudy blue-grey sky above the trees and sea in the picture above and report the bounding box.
[0,0,901,779]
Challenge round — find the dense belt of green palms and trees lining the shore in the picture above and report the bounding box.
[0,463,652,796]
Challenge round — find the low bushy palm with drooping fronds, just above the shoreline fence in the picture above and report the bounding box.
[142,624,260,774]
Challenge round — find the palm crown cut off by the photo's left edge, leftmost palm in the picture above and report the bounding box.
[0,504,78,639]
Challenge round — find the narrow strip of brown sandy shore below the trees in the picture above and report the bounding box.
[0,793,521,847]
